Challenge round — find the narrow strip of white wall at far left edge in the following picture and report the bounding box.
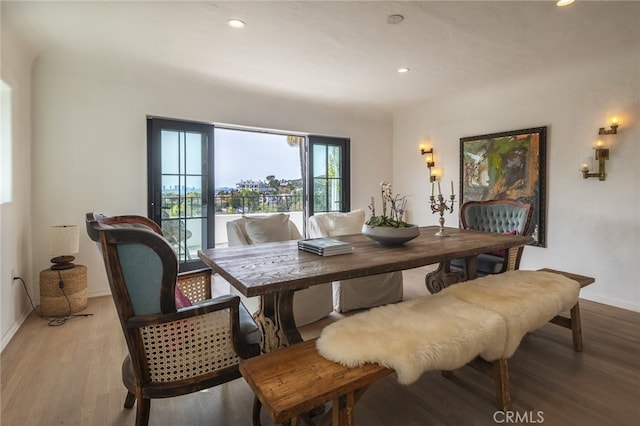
[0,20,33,348]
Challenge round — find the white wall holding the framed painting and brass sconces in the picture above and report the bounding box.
[394,49,640,310]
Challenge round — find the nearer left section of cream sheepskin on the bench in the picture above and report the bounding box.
[316,294,506,384]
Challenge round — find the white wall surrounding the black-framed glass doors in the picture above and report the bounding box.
[32,52,392,302]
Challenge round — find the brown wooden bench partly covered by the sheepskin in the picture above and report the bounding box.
[240,269,594,426]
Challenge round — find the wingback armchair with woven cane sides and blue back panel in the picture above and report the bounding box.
[86,213,260,426]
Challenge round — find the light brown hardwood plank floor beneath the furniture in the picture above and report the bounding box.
[0,268,640,426]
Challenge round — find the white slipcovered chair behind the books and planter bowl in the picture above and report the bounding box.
[308,210,402,312]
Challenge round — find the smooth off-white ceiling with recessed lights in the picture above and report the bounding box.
[2,0,640,110]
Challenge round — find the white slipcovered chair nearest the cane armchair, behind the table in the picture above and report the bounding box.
[227,213,333,327]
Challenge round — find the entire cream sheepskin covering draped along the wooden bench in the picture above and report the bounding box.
[316,270,580,384]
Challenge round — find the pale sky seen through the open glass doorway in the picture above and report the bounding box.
[214,127,301,188]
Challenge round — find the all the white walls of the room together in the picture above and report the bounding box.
[5,9,640,347]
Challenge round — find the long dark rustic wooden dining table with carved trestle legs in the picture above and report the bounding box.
[198,226,533,352]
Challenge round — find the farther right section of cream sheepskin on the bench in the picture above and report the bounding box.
[439,270,580,358]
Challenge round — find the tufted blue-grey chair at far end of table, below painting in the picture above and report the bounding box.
[451,200,532,275]
